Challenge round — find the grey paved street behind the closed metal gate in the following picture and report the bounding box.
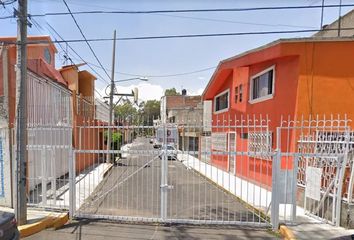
[79,138,263,223]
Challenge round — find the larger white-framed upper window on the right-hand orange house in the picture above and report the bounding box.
[250,66,274,101]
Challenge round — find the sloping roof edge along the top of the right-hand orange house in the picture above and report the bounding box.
[202,37,354,99]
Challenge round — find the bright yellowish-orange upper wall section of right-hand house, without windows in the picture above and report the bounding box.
[284,41,354,124]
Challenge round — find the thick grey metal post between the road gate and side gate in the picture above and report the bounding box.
[271,127,281,230]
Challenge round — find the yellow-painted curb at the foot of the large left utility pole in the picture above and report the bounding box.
[17,213,69,238]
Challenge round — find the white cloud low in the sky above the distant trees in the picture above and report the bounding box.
[95,83,164,101]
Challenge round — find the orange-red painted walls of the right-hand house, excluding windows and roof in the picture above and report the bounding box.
[204,41,354,186]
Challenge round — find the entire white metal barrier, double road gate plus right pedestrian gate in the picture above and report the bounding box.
[71,116,353,228]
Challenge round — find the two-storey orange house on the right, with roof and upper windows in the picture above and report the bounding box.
[202,38,354,186]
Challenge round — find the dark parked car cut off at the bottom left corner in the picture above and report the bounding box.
[0,211,20,240]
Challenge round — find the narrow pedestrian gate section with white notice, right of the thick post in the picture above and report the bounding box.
[273,116,353,226]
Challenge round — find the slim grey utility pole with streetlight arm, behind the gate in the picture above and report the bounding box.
[106,30,116,162]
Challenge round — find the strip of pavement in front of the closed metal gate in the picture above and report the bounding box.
[25,221,280,240]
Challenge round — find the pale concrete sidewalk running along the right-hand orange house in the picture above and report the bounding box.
[177,154,354,240]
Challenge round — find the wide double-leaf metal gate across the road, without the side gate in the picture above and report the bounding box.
[72,119,271,226]
